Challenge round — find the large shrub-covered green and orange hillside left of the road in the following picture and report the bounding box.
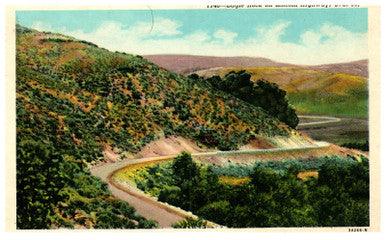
[16,26,290,229]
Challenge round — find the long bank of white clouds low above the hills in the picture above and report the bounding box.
[32,18,368,65]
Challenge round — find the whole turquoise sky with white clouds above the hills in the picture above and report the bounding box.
[16,8,368,65]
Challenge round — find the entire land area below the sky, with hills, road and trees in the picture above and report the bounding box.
[16,25,369,229]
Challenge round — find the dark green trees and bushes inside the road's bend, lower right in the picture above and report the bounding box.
[135,153,369,227]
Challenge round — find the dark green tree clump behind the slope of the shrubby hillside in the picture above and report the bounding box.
[204,70,299,128]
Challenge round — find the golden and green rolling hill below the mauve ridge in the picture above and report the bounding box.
[195,67,368,117]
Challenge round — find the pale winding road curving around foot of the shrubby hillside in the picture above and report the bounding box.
[90,142,330,228]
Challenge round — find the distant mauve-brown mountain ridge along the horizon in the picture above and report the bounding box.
[144,55,368,77]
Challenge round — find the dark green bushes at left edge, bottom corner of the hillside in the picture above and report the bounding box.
[17,138,66,228]
